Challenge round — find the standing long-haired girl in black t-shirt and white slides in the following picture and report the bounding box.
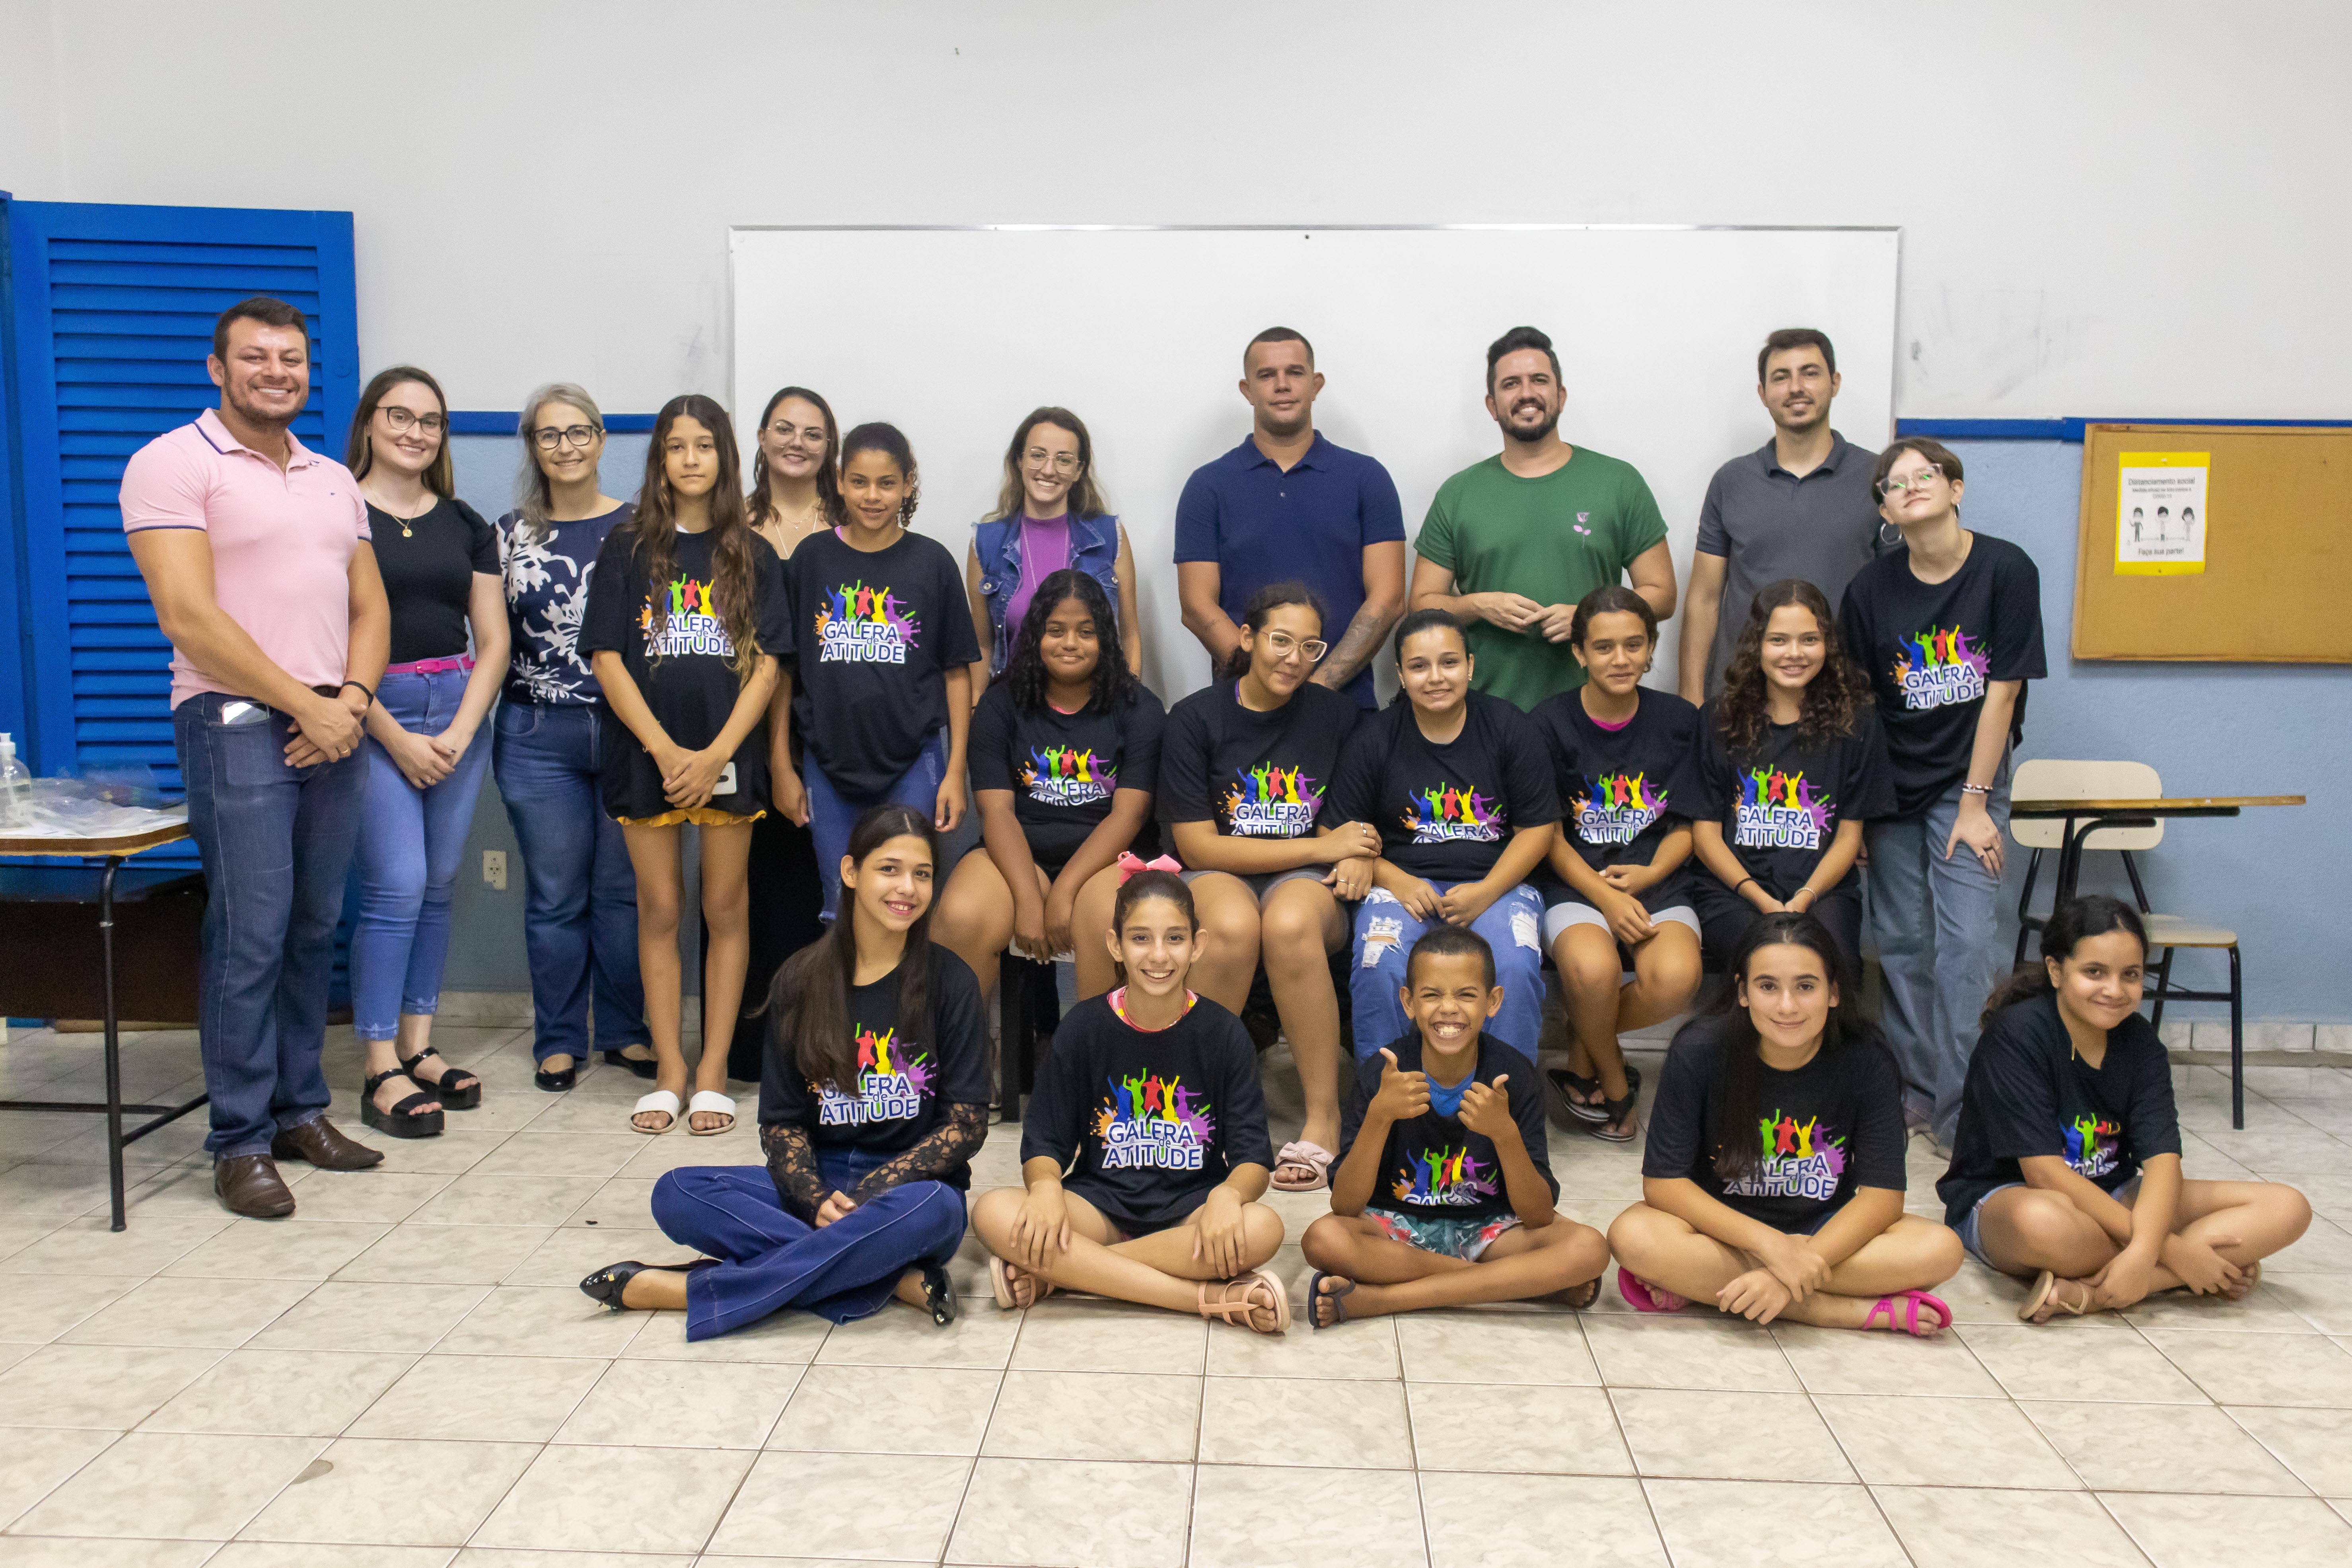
[581,395,790,1136]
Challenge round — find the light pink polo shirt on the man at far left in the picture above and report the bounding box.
[122,409,367,708]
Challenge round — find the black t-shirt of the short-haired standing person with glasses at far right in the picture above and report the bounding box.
[1837,534,2049,816]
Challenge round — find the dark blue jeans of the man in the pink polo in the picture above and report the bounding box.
[172,691,367,1159]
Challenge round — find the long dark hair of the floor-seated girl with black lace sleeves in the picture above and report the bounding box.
[760,804,941,1093]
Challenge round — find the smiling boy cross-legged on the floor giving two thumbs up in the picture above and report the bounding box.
[1301,926,1609,1328]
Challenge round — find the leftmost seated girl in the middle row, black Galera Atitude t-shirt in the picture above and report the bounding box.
[938,571,1167,997]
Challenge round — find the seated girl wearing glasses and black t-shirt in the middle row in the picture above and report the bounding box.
[1159,583,1381,1192]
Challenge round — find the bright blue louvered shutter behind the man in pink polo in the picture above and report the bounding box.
[7,202,360,832]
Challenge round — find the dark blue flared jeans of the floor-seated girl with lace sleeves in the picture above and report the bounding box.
[654,1159,964,1340]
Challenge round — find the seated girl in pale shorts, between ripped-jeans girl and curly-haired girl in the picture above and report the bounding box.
[1529,588,1698,1142]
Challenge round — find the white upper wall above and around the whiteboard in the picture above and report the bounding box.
[0,0,2352,416]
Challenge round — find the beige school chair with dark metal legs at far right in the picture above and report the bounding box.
[2009,757,2246,1128]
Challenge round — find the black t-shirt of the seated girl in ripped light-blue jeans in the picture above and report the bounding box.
[1322,691,1559,881]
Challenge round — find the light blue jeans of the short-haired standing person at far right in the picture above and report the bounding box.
[1863,757,2009,1147]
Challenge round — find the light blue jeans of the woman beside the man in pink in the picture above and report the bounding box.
[350,670,489,1039]
